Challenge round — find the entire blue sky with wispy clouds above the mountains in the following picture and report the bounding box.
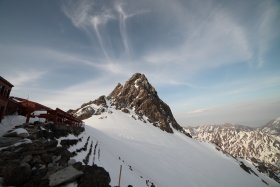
[0,0,280,126]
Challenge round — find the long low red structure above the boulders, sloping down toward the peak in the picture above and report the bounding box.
[7,97,83,127]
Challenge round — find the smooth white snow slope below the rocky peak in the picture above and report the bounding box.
[78,107,279,187]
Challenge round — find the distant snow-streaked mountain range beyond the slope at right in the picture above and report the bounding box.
[186,120,280,182]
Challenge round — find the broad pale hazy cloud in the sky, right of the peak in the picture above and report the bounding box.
[144,6,252,71]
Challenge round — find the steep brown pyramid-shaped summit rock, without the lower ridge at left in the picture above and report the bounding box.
[108,73,190,136]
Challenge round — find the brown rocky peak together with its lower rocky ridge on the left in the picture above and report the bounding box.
[68,73,191,137]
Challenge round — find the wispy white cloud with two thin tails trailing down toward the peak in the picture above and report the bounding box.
[63,0,146,62]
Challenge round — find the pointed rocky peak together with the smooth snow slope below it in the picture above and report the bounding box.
[68,73,279,187]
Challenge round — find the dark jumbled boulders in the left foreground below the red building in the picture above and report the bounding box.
[0,124,110,187]
